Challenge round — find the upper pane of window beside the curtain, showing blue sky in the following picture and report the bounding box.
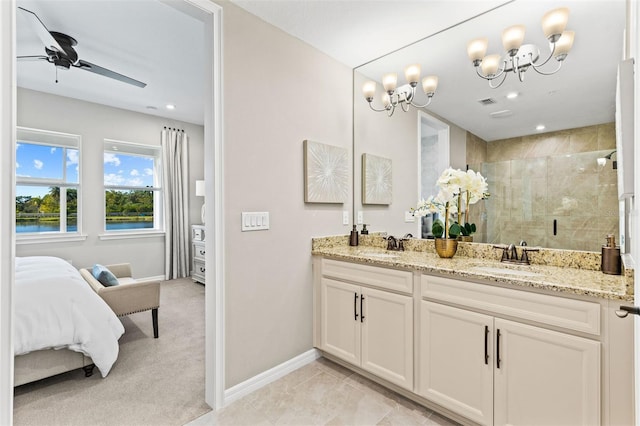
[104,152,155,187]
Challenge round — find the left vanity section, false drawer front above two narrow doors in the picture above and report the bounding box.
[319,260,414,390]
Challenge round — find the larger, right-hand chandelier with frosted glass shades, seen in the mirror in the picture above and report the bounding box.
[467,7,575,89]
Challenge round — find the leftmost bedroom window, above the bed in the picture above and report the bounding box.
[16,127,81,235]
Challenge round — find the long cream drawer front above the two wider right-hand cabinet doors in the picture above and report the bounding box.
[421,275,600,336]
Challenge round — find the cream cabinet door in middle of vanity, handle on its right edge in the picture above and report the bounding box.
[418,301,493,425]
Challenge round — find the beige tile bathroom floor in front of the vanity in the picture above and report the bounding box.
[189,358,457,426]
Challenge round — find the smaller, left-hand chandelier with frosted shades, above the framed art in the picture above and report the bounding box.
[362,64,438,117]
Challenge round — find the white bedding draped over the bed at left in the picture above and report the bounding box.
[14,256,124,377]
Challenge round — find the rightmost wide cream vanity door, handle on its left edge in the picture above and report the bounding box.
[494,318,600,425]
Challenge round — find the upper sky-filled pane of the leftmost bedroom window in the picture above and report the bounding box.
[16,142,63,182]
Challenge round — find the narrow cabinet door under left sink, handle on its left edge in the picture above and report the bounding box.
[361,288,413,391]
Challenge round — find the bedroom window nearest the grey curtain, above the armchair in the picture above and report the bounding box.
[104,139,163,232]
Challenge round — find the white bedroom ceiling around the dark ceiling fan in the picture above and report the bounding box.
[16,0,206,125]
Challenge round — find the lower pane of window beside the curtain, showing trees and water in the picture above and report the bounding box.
[105,189,155,231]
